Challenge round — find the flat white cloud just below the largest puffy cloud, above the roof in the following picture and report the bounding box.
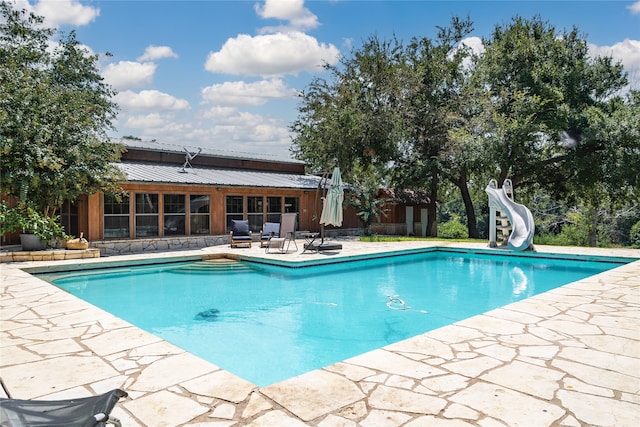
[202,79,296,106]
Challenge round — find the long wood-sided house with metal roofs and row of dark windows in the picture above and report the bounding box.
[4,139,432,255]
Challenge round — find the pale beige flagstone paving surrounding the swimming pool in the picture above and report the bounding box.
[0,240,640,427]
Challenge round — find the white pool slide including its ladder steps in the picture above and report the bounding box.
[485,179,535,251]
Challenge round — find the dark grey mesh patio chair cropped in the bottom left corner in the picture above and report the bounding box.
[0,389,127,427]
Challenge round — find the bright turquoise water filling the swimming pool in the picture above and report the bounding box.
[45,251,622,386]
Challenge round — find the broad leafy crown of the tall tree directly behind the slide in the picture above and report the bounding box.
[473,17,626,193]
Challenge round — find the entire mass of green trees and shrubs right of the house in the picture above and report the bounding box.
[291,16,640,246]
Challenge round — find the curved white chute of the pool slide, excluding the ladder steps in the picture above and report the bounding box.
[485,180,535,251]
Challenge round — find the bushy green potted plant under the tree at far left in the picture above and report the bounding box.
[0,202,67,251]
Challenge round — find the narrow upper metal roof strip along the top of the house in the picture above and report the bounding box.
[113,138,304,164]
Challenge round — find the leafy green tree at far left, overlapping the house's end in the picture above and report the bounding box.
[0,1,123,216]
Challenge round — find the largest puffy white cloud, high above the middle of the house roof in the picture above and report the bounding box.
[205,32,340,76]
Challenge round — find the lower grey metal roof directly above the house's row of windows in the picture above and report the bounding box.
[115,162,321,190]
